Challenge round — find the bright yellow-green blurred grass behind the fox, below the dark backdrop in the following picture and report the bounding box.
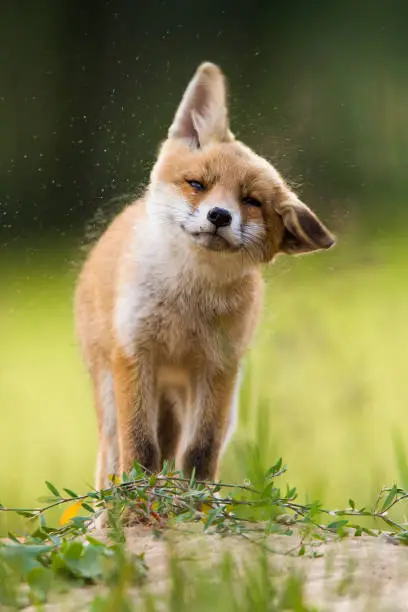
[0,237,408,527]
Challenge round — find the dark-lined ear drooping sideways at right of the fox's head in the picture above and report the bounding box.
[278,198,335,255]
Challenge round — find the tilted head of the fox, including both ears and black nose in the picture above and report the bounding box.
[148,63,334,265]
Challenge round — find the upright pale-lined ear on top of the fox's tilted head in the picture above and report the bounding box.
[169,62,234,148]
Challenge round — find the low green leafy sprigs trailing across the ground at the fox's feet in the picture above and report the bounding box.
[0,459,408,604]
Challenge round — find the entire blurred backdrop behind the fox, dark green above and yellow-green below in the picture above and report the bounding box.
[0,0,408,528]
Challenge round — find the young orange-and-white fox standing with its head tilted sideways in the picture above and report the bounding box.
[75,63,334,489]
